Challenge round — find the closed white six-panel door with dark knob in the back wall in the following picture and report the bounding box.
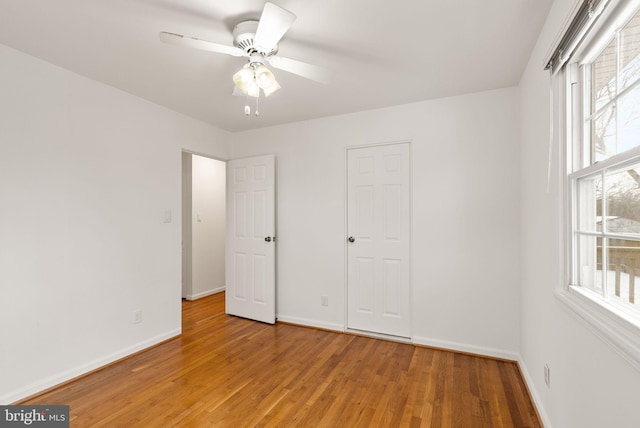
[347,143,411,337]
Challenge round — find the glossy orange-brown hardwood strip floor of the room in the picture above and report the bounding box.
[21,293,541,428]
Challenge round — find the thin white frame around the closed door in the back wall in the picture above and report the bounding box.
[343,139,415,343]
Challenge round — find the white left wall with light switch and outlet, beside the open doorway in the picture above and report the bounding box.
[0,45,228,404]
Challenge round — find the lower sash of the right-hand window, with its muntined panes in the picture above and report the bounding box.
[573,162,640,310]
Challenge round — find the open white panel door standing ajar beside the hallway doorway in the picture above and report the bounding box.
[225,155,276,324]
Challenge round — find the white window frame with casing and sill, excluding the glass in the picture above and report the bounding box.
[551,0,640,370]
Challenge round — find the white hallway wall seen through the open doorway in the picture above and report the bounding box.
[187,155,226,299]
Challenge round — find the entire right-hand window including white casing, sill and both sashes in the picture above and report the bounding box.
[547,0,640,370]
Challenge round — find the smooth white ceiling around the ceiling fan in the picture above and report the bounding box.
[0,0,552,131]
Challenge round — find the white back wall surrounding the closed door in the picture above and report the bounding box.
[231,88,520,358]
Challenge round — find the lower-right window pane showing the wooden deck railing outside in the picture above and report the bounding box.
[607,239,640,305]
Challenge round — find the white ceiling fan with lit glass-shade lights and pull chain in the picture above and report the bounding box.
[160,2,331,114]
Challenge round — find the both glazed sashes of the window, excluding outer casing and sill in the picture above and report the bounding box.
[569,5,640,320]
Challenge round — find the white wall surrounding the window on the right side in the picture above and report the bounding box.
[520,0,640,428]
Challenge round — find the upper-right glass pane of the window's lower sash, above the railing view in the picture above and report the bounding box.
[605,163,640,234]
